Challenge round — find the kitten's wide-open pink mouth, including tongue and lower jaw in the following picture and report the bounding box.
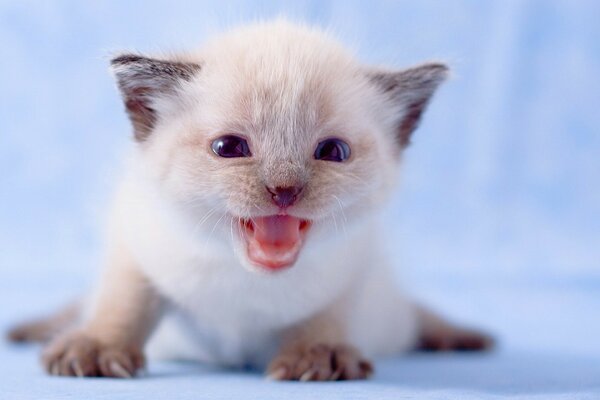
[240,215,311,271]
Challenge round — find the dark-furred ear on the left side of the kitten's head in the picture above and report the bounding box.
[110,54,200,141]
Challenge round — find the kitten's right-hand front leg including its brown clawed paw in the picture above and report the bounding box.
[267,309,373,381]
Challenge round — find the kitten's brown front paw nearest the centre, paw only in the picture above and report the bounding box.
[267,344,373,381]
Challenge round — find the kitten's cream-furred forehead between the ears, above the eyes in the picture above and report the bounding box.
[197,41,360,152]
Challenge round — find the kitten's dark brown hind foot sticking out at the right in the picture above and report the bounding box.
[417,306,494,351]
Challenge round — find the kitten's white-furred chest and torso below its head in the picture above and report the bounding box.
[111,157,417,366]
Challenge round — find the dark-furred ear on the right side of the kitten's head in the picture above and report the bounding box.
[369,63,449,148]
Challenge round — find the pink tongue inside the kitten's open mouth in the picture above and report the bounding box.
[254,215,301,250]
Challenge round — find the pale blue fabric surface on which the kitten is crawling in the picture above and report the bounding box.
[0,276,600,400]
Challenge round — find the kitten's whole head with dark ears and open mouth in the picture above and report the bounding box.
[112,22,447,271]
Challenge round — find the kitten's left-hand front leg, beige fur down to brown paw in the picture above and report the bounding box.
[42,244,161,378]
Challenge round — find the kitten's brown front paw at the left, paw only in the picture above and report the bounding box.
[42,332,144,378]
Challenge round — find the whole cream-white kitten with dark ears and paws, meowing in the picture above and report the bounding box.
[12,21,491,380]
